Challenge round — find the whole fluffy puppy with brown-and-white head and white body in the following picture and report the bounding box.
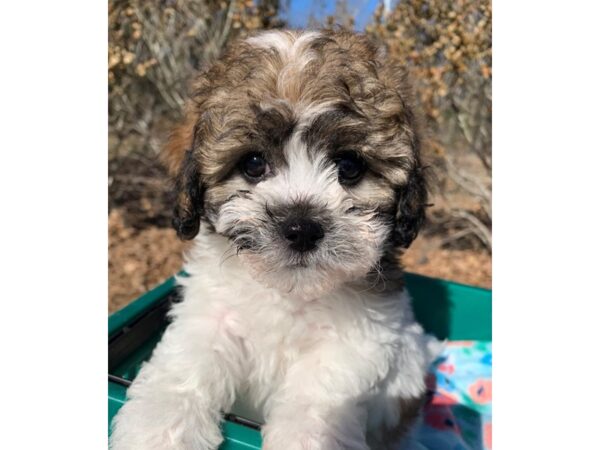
[111,31,435,450]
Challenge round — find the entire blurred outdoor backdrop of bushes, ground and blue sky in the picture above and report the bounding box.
[108,0,492,311]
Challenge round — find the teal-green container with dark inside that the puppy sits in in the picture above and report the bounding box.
[108,274,492,450]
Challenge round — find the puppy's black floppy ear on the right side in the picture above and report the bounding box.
[394,160,427,248]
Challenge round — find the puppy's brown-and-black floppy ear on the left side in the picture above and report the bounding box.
[163,115,204,240]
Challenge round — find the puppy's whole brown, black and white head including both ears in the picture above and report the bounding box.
[167,32,427,297]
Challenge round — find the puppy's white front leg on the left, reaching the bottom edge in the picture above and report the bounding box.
[110,312,241,450]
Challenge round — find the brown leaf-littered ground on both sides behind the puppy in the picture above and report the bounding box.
[108,208,492,312]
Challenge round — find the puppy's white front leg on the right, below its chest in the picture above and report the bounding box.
[263,342,377,450]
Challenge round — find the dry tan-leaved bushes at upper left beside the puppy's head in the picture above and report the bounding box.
[108,0,277,159]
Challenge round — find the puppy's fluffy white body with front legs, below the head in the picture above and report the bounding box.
[111,230,438,450]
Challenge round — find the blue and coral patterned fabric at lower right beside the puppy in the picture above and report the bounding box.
[403,341,492,450]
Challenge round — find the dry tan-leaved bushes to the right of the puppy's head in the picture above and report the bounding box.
[367,0,492,252]
